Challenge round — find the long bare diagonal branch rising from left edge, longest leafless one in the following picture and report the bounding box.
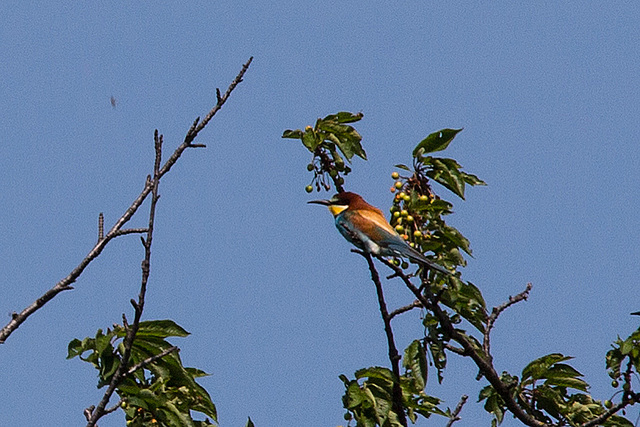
[0,57,253,344]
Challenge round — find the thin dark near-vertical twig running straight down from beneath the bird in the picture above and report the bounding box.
[357,251,407,427]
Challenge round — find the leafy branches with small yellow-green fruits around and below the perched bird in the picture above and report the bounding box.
[283,112,640,427]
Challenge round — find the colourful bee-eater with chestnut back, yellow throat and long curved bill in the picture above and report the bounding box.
[307,191,452,274]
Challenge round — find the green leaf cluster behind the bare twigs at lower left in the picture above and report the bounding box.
[67,320,217,427]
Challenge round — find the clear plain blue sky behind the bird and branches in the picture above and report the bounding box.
[0,0,640,427]
